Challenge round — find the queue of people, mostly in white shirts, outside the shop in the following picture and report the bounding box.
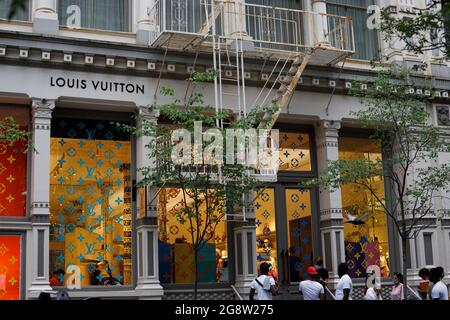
[250,257,450,301]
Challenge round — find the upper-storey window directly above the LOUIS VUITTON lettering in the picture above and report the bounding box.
[58,0,131,32]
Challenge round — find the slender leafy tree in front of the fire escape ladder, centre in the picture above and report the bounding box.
[118,70,276,300]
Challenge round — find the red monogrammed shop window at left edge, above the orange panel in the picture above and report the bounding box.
[0,105,30,217]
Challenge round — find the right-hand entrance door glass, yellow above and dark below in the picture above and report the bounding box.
[285,189,314,282]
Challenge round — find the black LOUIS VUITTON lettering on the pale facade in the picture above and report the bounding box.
[50,77,145,94]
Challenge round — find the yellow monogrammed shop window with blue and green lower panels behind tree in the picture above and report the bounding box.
[158,188,229,284]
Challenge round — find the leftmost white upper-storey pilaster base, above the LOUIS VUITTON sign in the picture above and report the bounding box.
[32,0,59,35]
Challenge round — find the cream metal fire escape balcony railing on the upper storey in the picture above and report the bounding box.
[150,0,355,61]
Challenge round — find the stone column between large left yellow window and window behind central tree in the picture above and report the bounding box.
[136,107,164,300]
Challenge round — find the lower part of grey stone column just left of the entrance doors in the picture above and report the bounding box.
[233,195,258,300]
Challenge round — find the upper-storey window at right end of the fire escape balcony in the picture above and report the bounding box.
[327,0,378,60]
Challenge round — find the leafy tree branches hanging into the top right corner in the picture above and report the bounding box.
[380,0,450,58]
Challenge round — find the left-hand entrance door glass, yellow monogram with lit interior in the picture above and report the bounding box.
[254,188,278,281]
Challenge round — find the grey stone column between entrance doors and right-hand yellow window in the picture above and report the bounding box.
[316,120,345,281]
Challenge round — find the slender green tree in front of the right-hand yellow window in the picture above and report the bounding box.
[306,65,450,298]
